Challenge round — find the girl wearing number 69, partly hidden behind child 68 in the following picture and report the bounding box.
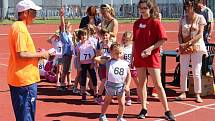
[122,31,140,106]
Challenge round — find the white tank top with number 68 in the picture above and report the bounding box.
[107,60,130,83]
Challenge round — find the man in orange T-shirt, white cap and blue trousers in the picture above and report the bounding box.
[8,0,53,121]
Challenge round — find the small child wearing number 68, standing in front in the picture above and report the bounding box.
[95,43,131,121]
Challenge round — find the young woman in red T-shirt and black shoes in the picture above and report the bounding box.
[133,0,175,121]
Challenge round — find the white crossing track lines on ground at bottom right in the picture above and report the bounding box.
[155,102,215,121]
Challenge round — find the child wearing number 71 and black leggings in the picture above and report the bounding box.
[78,29,97,102]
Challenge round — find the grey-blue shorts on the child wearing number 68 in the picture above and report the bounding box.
[105,81,125,96]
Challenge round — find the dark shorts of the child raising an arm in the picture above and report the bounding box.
[63,56,72,74]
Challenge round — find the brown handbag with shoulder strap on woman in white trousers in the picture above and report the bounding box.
[179,18,197,54]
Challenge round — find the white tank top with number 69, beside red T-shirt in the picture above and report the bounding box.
[123,45,132,64]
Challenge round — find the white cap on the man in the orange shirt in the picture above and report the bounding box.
[16,0,42,13]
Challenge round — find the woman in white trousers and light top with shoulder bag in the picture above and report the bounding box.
[176,0,207,103]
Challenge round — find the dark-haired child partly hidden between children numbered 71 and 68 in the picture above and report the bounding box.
[95,29,111,104]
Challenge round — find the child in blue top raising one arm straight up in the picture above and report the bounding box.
[60,8,74,90]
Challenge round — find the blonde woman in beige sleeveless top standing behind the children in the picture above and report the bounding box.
[100,4,118,42]
